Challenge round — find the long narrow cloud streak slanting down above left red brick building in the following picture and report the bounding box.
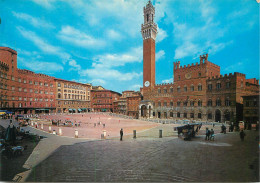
[17,27,70,62]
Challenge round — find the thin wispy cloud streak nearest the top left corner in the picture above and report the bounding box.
[12,11,55,28]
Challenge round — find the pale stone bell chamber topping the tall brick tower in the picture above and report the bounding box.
[141,1,157,40]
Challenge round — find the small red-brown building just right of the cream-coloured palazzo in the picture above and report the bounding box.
[91,89,121,112]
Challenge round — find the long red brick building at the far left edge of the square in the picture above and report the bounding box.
[0,47,55,114]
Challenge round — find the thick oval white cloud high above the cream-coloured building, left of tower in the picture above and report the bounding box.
[57,26,106,49]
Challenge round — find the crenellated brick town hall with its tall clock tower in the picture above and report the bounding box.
[139,1,259,122]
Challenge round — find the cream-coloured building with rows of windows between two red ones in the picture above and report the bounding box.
[54,79,91,113]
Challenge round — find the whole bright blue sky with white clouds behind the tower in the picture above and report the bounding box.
[0,0,259,92]
